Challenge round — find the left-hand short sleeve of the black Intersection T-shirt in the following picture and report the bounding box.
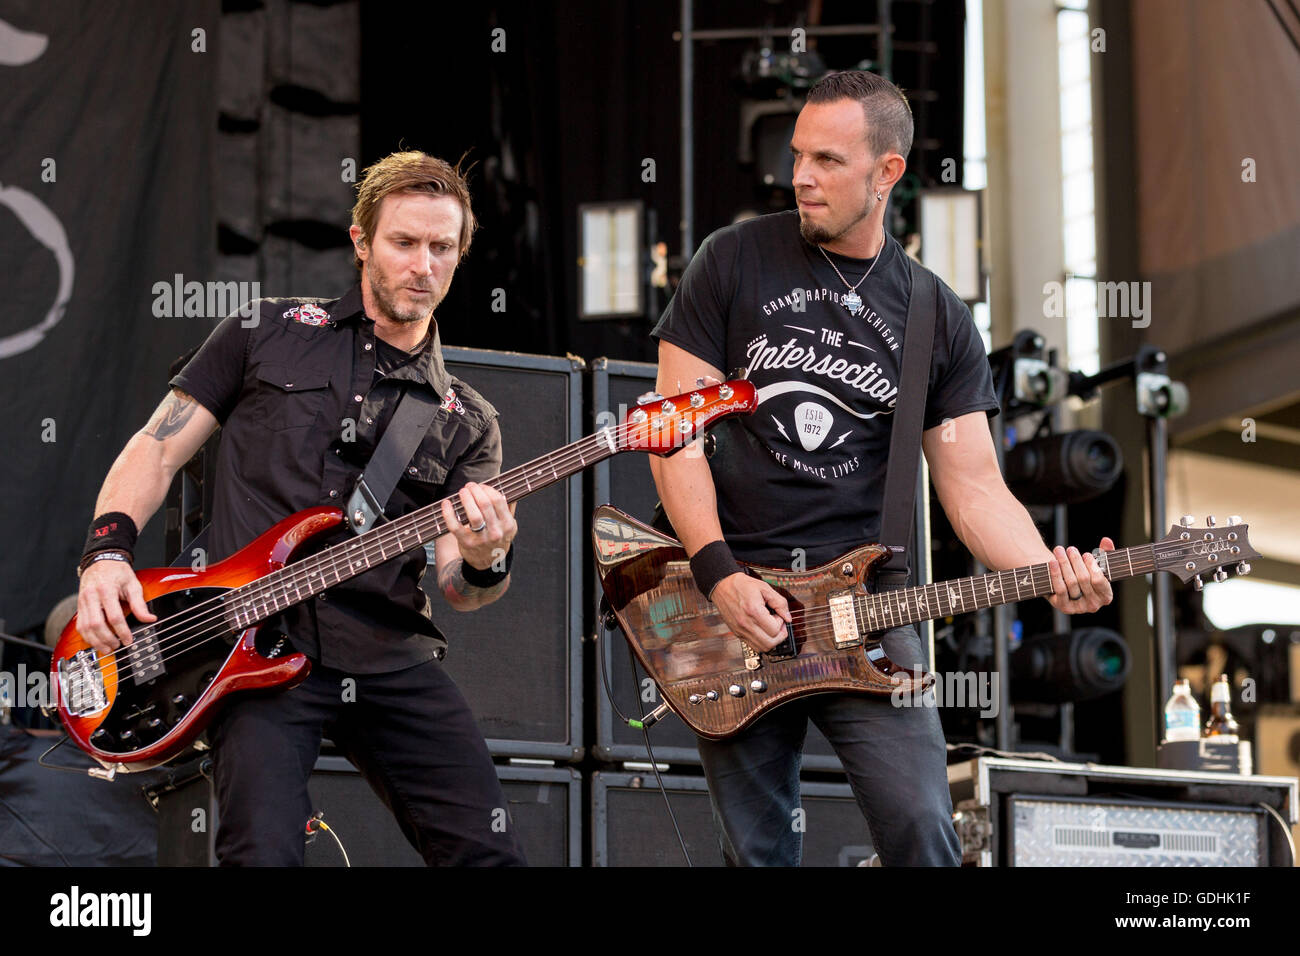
[650,233,736,373]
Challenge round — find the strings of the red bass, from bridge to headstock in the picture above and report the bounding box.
[78,424,637,679]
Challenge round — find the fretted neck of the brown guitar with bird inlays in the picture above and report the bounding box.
[857,545,1156,631]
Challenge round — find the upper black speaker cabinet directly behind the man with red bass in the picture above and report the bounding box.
[436,349,585,761]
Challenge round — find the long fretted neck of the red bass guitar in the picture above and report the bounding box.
[224,428,624,628]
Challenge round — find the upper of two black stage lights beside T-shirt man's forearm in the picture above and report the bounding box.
[1002,431,1125,505]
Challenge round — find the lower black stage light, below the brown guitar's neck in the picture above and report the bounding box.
[1011,627,1128,704]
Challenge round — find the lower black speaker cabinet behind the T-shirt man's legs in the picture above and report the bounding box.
[592,773,875,866]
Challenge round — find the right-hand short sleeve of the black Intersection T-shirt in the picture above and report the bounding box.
[924,284,1000,429]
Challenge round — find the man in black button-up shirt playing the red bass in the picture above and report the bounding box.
[78,152,524,865]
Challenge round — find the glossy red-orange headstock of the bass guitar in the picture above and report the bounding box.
[618,378,758,455]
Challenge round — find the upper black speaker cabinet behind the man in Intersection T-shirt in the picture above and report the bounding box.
[582,359,841,770]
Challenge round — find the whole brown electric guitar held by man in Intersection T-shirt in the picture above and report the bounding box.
[592,505,1260,740]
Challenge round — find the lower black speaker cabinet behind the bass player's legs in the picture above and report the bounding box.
[153,757,582,866]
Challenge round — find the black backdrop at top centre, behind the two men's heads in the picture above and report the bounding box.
[361,0,965,362]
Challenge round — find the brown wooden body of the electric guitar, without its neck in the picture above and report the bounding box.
[592,505,933,739]
